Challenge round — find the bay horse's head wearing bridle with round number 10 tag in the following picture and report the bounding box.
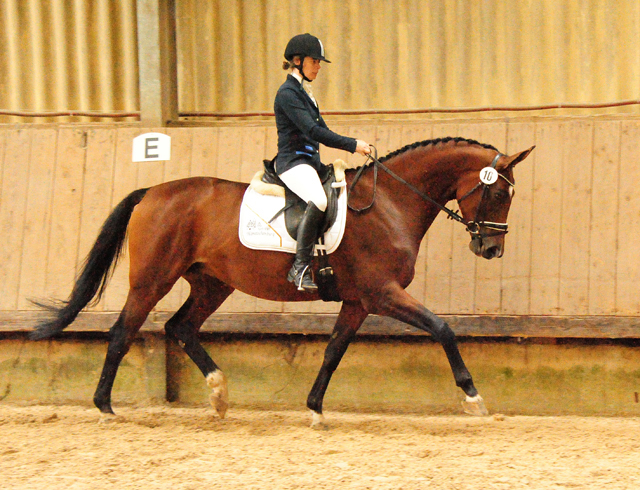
[456,146,535,259]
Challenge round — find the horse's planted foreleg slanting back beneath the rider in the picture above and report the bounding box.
[307,302,367,426]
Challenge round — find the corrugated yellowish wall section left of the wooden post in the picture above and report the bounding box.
[0,0,139,122]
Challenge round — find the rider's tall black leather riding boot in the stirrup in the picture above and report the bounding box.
[287,202,324,292]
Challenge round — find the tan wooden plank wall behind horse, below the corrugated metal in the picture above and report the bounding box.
[0,117,640,326]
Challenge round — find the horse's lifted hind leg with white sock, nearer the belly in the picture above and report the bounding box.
[165,272,233,418]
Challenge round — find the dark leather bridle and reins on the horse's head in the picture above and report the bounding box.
[347,149,515,240]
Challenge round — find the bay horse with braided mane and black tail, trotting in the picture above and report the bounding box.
[32,138,533,425]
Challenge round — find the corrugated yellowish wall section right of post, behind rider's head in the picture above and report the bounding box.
[177,0,640,112]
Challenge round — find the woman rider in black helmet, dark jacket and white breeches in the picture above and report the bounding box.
[274,34,371,291]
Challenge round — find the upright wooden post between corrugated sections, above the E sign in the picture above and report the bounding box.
[136,0,178,127]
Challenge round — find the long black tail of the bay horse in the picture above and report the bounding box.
[30,189,149,340]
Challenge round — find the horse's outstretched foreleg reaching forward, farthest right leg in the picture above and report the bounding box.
[377,290,488,415]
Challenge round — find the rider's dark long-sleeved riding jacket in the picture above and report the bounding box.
[274,75,357,174]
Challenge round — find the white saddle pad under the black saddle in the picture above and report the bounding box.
[238,183,347,255]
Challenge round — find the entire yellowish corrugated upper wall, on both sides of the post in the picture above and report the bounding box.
[0,0,640,122]
